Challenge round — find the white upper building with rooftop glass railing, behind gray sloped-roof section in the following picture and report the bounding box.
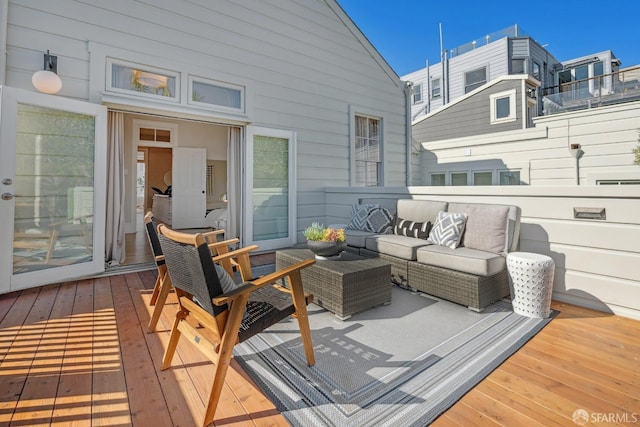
[402,25,620,120]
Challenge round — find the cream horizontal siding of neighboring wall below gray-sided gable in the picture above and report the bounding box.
[414,102,640,186]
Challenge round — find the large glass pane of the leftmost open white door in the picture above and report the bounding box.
[13,104,95,274]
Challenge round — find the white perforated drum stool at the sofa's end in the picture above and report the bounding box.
[507,252,555,318]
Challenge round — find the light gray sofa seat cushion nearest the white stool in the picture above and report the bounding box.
[416,245,507,276]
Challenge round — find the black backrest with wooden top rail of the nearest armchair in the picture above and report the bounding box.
[157,224,227,316]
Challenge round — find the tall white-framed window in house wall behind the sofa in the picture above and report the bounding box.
[355,115,382,187]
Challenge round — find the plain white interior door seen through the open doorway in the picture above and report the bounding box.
[171,147,207,229]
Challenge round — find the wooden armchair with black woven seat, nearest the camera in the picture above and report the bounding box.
[158,224,315,425]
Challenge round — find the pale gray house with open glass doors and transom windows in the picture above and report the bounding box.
[0,0,410,292]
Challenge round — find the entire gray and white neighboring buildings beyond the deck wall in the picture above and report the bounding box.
[403,26,640,186]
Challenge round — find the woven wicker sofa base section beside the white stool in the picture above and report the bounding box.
[409,261,509,311]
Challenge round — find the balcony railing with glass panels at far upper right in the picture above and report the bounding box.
[542,67,640,115]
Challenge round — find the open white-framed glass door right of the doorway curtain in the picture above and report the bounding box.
[244,126,297,250]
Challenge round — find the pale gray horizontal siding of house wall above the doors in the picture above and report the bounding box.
[6,0,406,234]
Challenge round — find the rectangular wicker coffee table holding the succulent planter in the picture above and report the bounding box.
[276,249,391,320]
